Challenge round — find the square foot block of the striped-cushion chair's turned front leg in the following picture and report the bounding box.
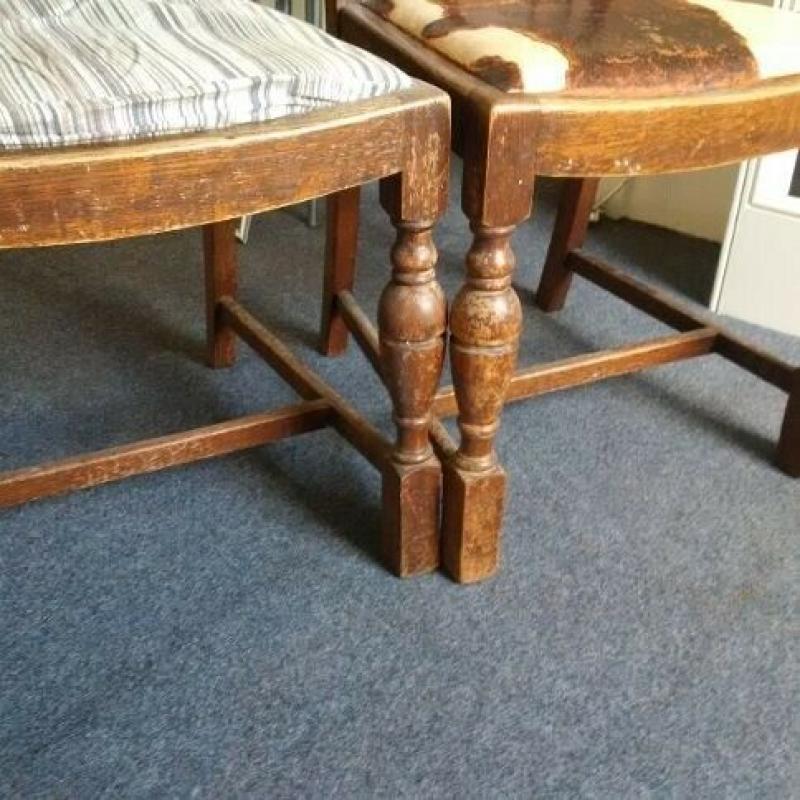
[381,456,442,578]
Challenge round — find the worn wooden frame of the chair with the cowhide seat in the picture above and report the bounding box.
[324,0,800,581]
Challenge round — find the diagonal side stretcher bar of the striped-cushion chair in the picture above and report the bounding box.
[220,297,391,469]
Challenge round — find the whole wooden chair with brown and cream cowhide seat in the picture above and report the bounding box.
[322,0,800,582]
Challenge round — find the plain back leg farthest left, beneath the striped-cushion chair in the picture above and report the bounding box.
[203,220,238,368]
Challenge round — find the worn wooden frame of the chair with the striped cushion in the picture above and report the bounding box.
[0,0,450,576]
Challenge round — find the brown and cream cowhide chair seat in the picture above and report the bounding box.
[367,0,800,96]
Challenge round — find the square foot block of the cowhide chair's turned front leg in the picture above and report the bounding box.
[442,464,507,583]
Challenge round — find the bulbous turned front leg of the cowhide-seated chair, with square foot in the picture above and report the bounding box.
[442,224,522,583]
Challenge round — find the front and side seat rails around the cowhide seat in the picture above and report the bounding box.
[338,2,800,175]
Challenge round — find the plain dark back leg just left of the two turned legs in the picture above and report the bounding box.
[319,186,361,356]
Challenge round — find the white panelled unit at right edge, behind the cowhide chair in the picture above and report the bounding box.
[712,0,800,336]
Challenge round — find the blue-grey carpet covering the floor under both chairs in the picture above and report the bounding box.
[0,172,800,800]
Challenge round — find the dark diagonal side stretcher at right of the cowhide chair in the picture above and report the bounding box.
[567,253,795,392]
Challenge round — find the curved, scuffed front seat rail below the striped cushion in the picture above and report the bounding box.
[0,83,449,248]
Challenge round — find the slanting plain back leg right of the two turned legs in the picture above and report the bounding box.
[536,178,599,311]
